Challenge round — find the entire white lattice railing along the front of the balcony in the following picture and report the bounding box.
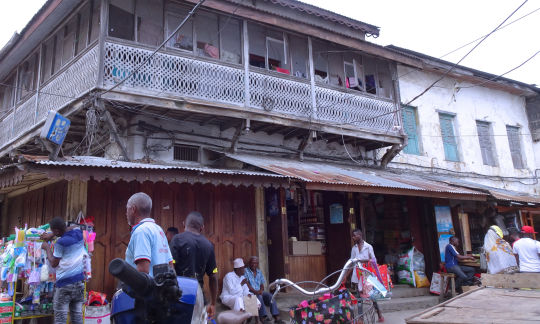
[103,42,399,134]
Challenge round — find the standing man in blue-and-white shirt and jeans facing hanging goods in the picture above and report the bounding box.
[41,217,88,324]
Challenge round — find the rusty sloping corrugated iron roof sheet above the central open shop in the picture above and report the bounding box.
[227,154,486,196]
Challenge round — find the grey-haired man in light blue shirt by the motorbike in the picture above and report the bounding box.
[126,192,173,276]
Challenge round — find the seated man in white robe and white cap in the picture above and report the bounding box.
[220,258,260,318]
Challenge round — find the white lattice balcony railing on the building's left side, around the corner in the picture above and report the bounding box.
[0,46,99,148]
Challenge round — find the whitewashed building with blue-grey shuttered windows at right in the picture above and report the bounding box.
[388,46,540,262]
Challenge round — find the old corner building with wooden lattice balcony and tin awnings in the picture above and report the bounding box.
[0,0,534,293]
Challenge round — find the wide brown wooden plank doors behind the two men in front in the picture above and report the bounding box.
[87,181,257,294]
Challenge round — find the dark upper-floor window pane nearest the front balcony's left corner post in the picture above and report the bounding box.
[109,0,135,40]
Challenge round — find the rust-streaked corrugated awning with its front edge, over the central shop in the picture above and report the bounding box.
[226,154,487,200]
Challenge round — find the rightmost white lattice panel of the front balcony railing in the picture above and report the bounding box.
[315,87,399,134]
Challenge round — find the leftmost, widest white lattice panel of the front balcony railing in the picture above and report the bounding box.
[104,43,244,104]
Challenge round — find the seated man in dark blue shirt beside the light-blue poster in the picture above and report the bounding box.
[444,236,476,293]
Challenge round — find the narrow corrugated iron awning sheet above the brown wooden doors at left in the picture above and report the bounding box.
[20,155,286,178]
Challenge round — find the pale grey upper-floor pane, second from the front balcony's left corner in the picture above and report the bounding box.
[135,0,163,46]
